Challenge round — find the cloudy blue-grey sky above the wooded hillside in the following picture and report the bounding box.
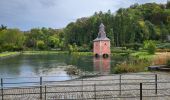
[0,0,167,31]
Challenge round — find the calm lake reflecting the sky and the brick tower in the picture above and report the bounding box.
[0,54,126,86]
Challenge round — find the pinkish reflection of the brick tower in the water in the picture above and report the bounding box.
[93,57,110,74]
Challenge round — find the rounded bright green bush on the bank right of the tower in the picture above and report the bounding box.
[144,40,156,54]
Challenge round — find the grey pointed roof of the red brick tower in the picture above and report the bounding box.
[94,23,110,41]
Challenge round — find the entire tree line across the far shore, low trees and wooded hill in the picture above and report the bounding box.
[0,2,170,52]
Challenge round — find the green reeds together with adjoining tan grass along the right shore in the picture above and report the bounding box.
[113,51,170,73]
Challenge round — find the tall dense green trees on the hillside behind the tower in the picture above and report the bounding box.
[65,3,170,50]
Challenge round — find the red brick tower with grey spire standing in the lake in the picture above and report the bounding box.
[93,23,110,57]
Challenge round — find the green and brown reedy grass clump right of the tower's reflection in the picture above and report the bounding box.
[113,51,156,73]
